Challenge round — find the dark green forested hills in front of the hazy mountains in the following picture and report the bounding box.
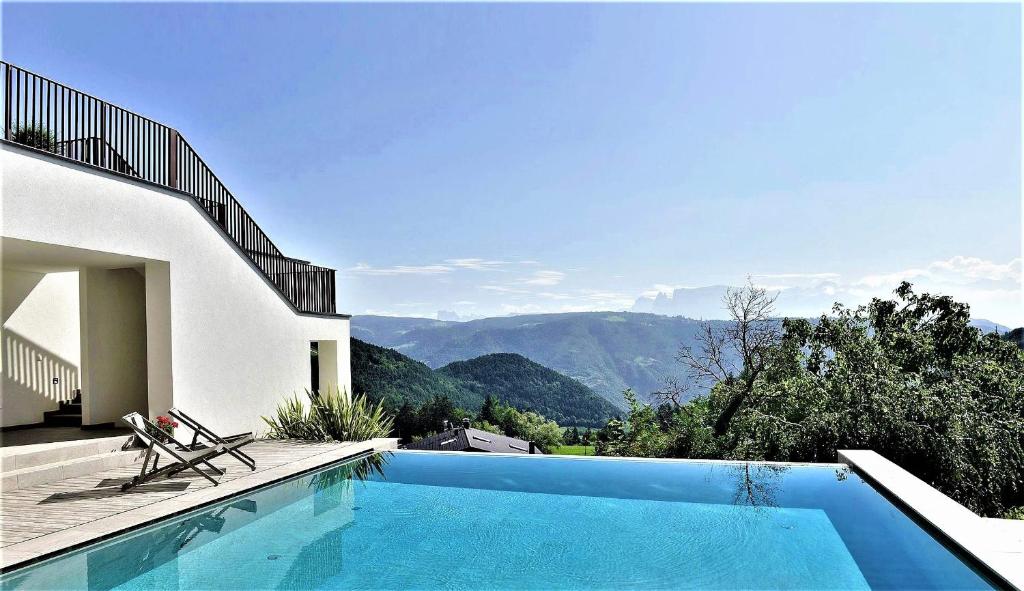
[351,338,620,427]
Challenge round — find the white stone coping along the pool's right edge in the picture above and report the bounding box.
[839,450,1024,591]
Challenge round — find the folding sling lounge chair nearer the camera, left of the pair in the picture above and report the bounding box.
[121,413,235,491]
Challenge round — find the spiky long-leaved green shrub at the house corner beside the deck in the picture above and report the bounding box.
[263,388,394,441]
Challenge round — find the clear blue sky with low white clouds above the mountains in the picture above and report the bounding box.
[2,3,1024,325]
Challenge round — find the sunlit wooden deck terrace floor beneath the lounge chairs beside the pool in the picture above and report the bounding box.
[0,439,396,571]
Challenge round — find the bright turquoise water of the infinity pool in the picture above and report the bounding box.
[0,452,992,589]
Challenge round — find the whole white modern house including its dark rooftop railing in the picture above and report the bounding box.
[0,62,351,432]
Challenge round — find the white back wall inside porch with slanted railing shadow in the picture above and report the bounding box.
[0,269,81,427]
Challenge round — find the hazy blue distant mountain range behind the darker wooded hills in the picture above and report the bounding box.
[351,311,1009,409]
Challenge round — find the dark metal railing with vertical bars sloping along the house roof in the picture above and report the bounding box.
[0,61,335,313]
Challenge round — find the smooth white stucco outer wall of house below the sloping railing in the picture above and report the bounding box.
[0,144,351,432]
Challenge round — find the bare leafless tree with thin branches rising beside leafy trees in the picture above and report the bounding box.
[675,281,779,436]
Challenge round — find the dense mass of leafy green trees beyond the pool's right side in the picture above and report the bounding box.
[614,283,1024,516]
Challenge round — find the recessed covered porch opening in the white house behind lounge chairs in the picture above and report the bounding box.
[0,237,171,440]
